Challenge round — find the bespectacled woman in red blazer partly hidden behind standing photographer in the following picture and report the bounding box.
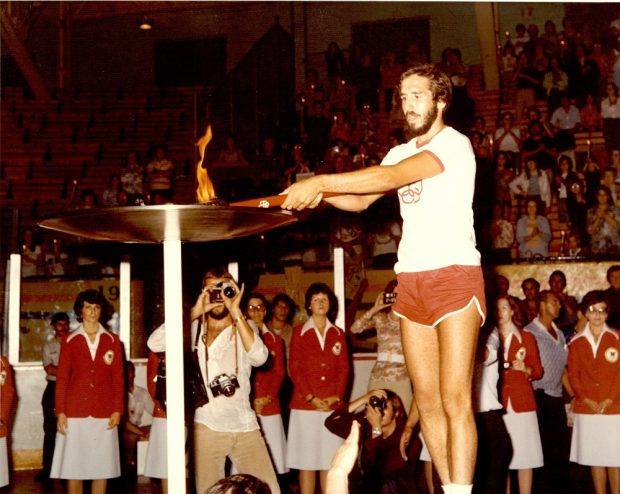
[245,293,288,475]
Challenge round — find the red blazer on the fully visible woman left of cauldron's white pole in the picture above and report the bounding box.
[55,326,125,418]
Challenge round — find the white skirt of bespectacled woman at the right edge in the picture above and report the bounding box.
[570,413,620,468]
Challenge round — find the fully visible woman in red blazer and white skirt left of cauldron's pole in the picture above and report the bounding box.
[50,290,125,494]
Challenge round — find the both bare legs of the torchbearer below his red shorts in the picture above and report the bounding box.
[401,303,480,485]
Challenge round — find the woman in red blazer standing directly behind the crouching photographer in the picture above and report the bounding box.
[286,283,349,494]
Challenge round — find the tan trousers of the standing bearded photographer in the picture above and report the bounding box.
[194,422,280,494]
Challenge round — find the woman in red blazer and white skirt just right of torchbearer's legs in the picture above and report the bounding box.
[495,296,543,494]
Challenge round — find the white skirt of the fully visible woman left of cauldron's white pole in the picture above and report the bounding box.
[50,417,121,480]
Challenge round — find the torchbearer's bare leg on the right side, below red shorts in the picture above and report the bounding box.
[438,303,481,484]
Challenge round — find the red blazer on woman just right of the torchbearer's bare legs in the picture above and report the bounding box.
[500,329,543,412]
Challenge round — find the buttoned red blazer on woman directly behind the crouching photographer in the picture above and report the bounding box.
[289,318,349,410]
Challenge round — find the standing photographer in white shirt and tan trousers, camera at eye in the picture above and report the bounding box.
[190,268,280,494]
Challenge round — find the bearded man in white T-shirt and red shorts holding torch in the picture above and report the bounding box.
[282,64,486,494]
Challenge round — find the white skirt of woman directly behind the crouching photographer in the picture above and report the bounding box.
[286,410,344,470]
